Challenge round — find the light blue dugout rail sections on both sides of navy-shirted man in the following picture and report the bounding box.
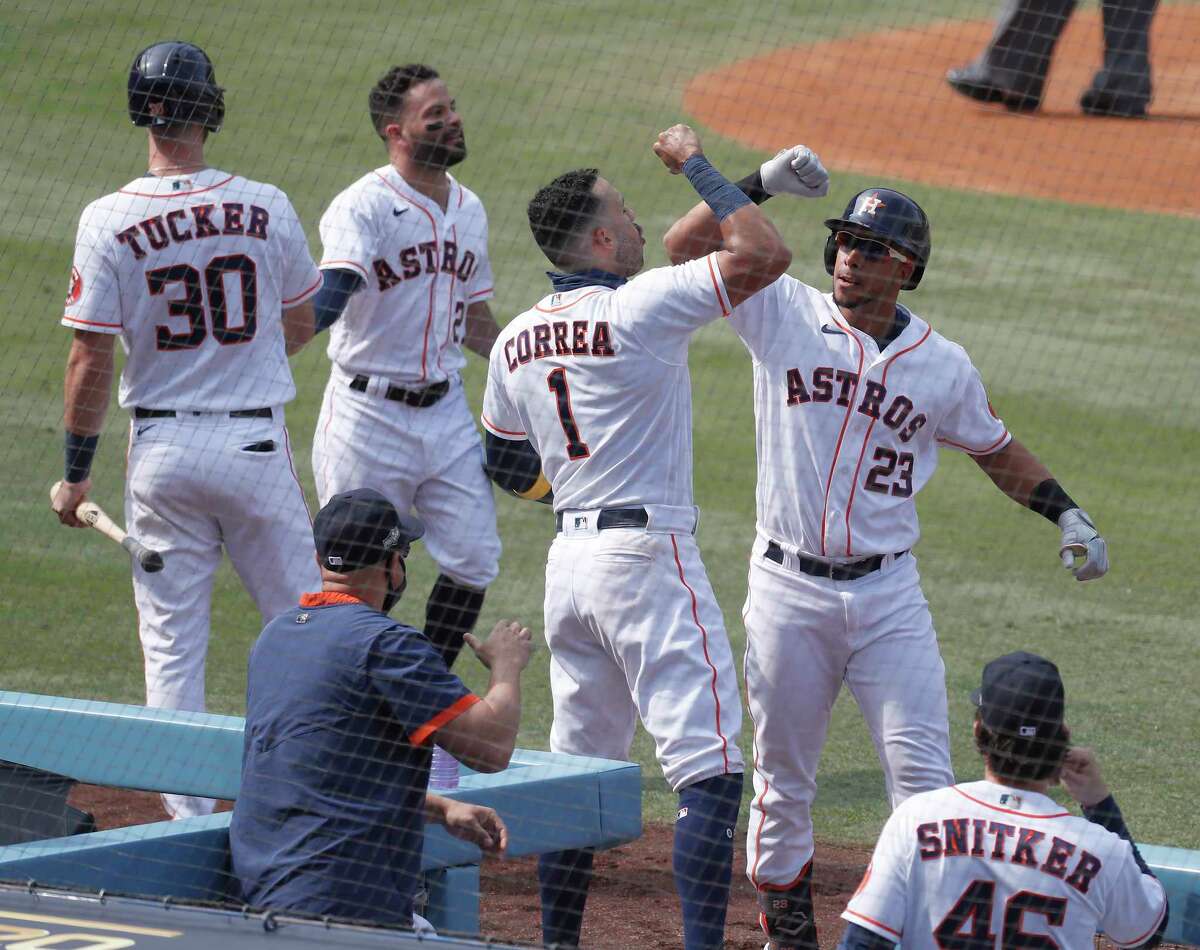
[0,691,642,933]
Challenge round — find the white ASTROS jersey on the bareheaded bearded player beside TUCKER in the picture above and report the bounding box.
[320,164,493,386]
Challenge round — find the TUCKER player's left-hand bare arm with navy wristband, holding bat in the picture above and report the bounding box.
[50,330,116,528]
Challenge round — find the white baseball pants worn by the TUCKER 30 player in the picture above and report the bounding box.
[125,409,320,818]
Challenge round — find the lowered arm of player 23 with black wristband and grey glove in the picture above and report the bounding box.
[972,439,1109,581]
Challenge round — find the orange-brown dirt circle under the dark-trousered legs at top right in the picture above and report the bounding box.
[684,6,1200,216]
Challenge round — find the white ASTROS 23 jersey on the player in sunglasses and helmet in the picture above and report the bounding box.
[730,275,1010,561]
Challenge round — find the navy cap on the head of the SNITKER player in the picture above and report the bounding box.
[971,651,1067,740]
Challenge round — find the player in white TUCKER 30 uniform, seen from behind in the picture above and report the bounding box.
[53,42,320,817]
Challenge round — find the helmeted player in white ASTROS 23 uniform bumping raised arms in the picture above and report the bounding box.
[666,166,1108,949]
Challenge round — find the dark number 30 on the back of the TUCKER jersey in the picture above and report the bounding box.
[146,254,258,351]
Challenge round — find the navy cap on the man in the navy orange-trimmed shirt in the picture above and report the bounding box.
[312,488,425,573]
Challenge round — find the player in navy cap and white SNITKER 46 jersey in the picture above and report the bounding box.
[839,653,1168,950]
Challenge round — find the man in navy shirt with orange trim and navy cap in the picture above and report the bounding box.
[229,488,530,927]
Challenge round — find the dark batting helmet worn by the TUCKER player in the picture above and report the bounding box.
[128,40,224,132]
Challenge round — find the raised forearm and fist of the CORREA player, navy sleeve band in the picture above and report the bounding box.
[654,125,792,306]
